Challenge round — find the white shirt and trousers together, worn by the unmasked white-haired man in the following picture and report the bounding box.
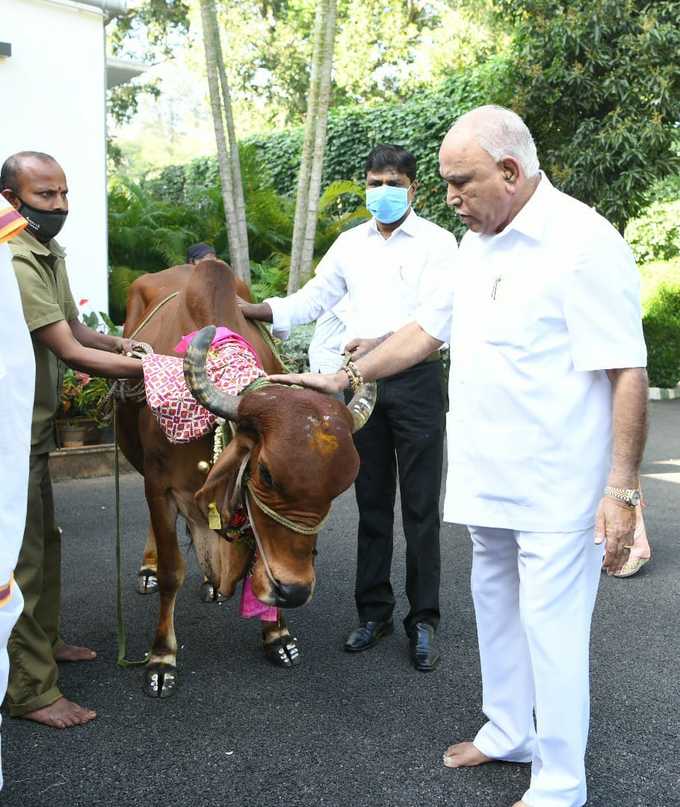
[444,176,646,807]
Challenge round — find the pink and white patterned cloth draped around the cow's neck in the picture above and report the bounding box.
[142,327,265,443]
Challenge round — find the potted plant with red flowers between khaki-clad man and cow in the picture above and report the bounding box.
[57,369,109,448]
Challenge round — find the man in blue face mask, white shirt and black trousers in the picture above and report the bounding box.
[242,145,457,672]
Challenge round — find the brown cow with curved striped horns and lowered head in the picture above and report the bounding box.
[118,260,375,698]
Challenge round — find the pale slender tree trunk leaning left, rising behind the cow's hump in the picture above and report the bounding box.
[200,0,250,283]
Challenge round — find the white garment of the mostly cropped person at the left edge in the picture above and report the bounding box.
[0,244,35,787]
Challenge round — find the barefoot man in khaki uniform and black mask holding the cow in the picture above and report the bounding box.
[0,152,142,728]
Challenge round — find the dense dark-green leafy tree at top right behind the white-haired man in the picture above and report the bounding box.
[495,0,680,231]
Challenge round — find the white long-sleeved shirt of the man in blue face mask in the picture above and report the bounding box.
[266,211,458,342]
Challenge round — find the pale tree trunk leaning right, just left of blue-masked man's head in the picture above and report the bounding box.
[288,0,337,294]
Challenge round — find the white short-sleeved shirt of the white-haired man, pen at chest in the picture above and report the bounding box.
[444,175,647,532]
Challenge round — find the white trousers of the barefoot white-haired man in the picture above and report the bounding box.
[469,527,603,807]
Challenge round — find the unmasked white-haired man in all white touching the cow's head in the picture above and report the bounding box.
[272,107,647,807]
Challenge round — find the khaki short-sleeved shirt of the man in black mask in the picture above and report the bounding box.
[9,232,78,454]
